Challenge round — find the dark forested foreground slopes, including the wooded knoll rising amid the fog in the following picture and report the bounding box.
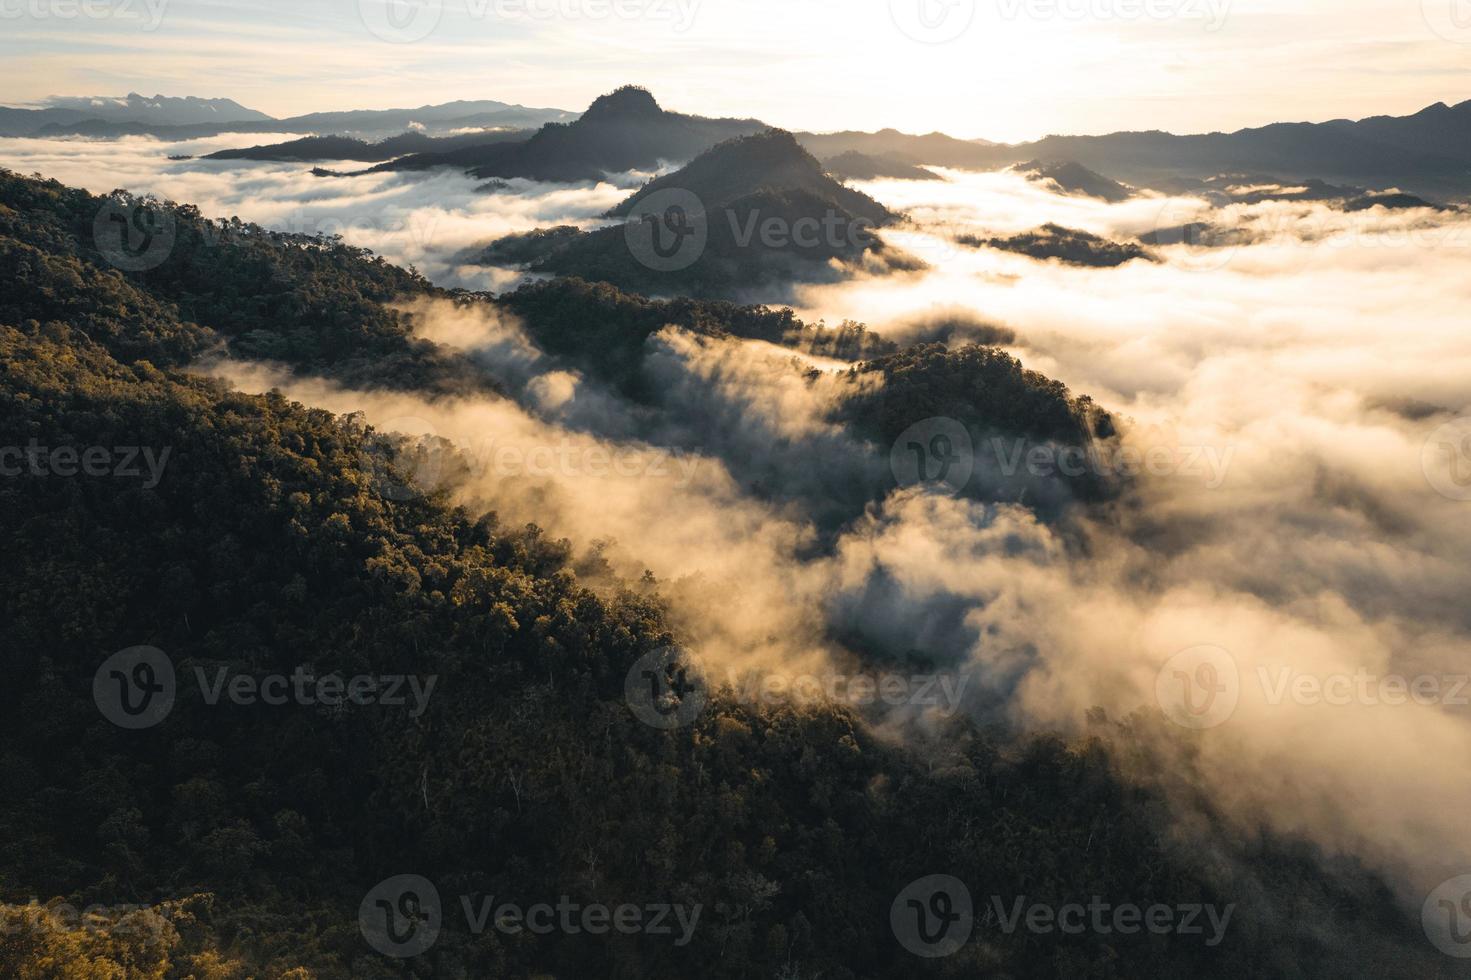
[0,174,1436,980]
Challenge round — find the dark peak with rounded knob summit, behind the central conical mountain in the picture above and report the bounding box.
[378,85,765,181]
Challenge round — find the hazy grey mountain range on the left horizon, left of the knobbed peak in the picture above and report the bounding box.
[0,93,577,140]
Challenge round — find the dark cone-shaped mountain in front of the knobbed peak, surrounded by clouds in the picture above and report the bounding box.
[474,129,912,297]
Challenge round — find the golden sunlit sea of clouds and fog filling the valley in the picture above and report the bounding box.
[0,135,1471,924]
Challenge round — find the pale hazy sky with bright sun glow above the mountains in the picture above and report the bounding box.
[0,0,1471,141]
